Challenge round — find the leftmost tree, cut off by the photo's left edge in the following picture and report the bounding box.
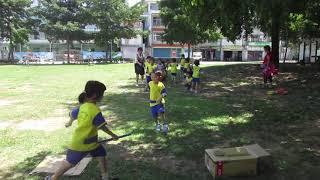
[0,0,35,63]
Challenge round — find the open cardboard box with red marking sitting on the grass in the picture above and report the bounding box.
[205,144,270,178]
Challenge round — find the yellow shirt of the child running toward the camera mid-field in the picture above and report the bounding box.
[149,81,167,107]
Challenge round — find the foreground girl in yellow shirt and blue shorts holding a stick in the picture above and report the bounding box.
[45,81,118,180]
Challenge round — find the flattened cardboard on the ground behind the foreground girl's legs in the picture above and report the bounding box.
[30,155,92,176]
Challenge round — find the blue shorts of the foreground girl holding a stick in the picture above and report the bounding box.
[67,145,107,165]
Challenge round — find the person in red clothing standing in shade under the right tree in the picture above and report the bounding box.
[261,46,277,87]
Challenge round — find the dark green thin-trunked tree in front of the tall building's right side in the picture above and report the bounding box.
[160,0,220,57]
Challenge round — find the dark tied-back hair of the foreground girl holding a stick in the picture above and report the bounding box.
[78,81,107,104]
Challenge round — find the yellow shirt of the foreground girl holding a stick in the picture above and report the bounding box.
[69,103,101,151]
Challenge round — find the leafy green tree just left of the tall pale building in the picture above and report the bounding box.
[89,0,145,59]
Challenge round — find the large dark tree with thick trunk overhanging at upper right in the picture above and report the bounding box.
[180,0,310,66]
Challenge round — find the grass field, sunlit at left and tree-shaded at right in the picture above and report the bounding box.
[0,64,320,180]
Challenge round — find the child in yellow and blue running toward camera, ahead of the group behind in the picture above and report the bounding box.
[149,72,169,134]
